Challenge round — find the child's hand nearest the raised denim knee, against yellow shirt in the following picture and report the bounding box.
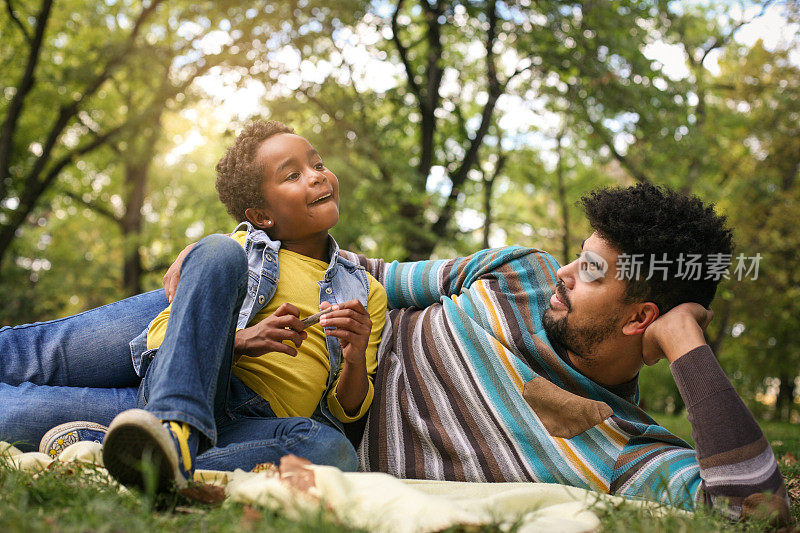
[234,303,308,357]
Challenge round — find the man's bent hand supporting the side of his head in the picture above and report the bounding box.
[642,303,714,365]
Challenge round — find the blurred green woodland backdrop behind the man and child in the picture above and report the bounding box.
[0,0,800,419]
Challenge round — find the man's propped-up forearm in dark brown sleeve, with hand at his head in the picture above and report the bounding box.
[644,304,789,518]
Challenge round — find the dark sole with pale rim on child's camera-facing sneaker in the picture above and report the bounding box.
[103,409,188,493]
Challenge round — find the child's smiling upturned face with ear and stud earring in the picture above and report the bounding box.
[245,133,339,241]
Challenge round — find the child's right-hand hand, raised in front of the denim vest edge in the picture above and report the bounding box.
[319,300,372,364]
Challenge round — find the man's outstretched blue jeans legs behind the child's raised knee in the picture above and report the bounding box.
[0,284,162,451]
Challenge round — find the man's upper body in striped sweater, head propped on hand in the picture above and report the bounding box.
[166,185,788,518]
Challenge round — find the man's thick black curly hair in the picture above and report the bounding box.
[581,183,733,315]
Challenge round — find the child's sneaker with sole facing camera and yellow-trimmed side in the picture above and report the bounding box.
[103,409,198,492]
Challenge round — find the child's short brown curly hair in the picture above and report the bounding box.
[216,120,294,222]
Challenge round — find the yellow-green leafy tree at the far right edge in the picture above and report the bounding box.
[715,42,800,420]
